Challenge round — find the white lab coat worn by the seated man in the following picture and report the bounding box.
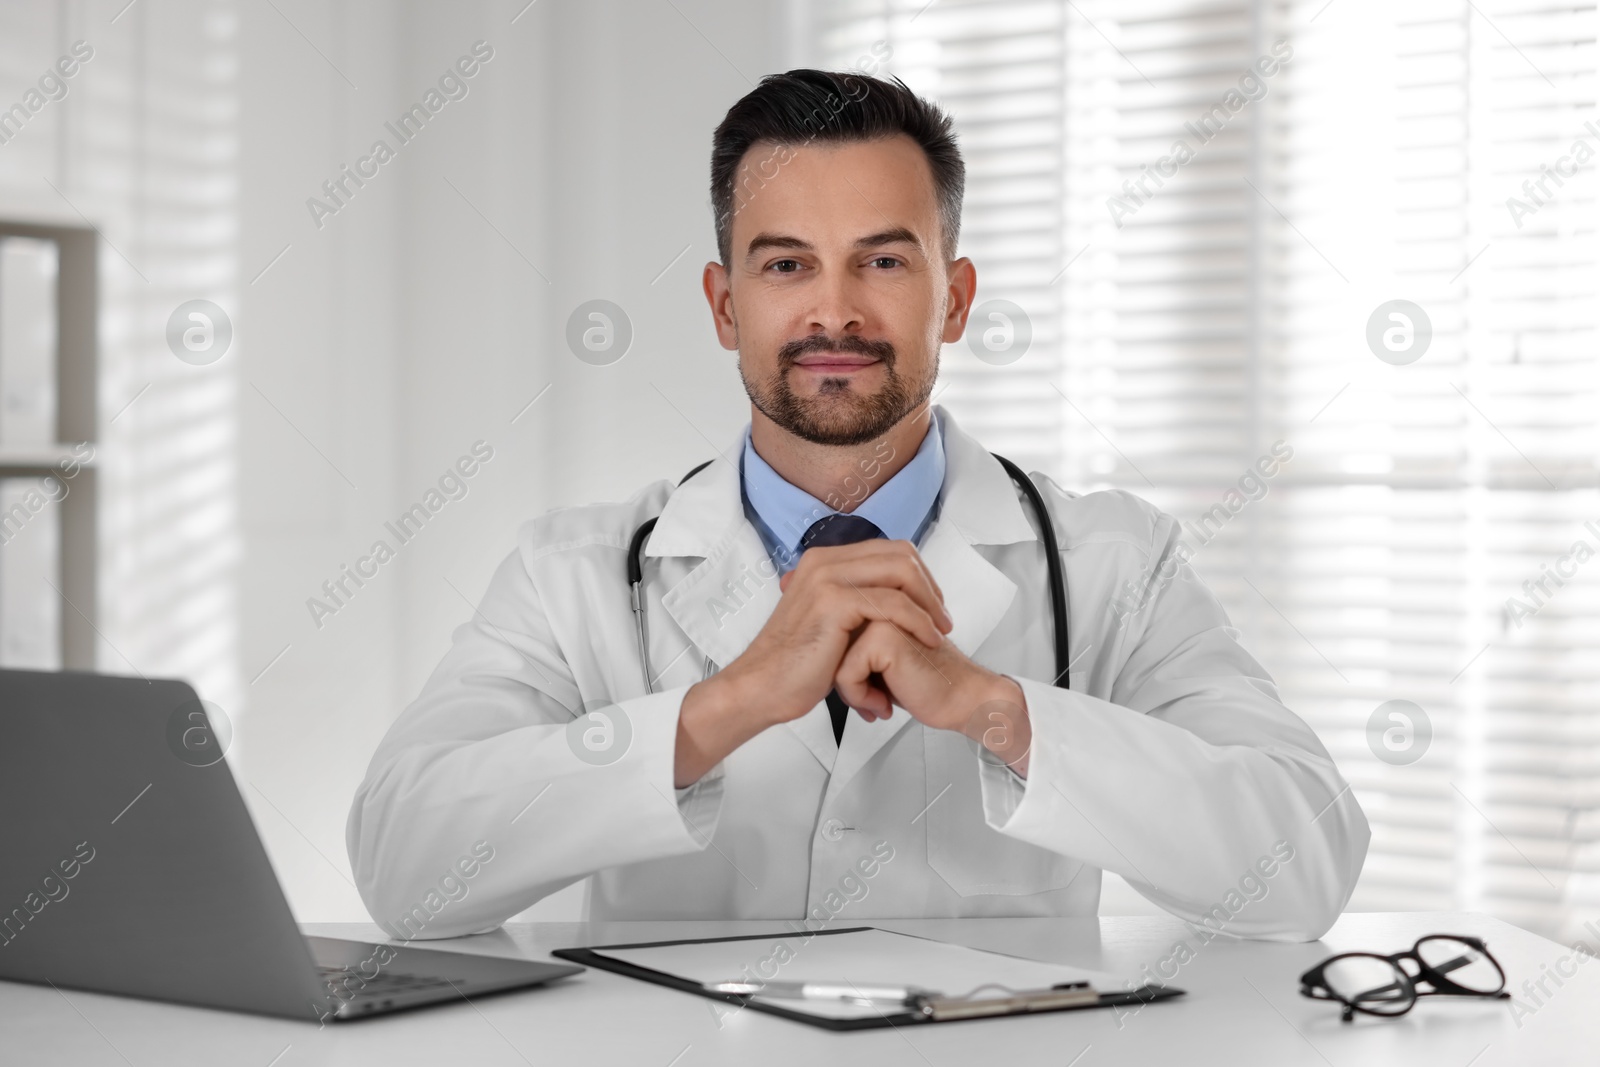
[347,410,1370,941]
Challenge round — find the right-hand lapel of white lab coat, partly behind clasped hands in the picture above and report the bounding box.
[824,408,1037,805]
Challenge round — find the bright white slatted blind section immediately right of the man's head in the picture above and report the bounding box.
[806,0,1067,469]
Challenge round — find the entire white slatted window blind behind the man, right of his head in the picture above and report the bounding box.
[806,0,1600,939]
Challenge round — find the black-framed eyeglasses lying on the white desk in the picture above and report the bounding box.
[1301,934,1510,1022]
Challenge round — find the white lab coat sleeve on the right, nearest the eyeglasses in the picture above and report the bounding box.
[981,515,1371,941]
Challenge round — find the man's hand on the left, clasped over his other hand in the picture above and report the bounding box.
[674,539,954,789]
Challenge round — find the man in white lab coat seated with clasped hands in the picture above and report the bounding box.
[347,70,1370,941]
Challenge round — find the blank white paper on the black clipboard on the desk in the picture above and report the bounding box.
[595,928,1128,1019]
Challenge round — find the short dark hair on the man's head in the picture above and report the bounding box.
[710,69,966,266]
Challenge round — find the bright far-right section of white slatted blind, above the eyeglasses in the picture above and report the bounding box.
[1261,0,1600,937]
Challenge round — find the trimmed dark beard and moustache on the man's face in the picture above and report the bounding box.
[739,334,939,446]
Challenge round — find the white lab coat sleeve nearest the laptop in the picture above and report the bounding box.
[346,552,723,939]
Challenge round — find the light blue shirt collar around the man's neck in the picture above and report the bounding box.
[739,411,944,574]
